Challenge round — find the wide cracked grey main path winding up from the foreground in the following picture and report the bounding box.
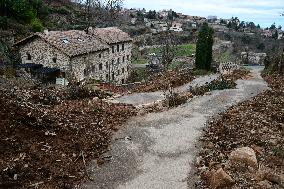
[80,67,267,189]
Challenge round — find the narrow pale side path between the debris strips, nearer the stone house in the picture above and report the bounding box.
[115,74,219,105]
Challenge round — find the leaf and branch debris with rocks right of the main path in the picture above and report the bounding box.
[195,75,284,189]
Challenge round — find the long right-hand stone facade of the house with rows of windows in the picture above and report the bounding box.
[71,42,132,84]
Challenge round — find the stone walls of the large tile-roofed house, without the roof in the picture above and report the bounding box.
[20,38,132,84]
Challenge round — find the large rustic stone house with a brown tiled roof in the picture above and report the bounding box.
[15,27,132,84]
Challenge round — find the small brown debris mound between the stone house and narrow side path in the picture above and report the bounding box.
[131,71,194,92]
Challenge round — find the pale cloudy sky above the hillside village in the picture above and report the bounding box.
[124,0,284,28]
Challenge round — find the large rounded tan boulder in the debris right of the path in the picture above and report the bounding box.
[229,147,258,168]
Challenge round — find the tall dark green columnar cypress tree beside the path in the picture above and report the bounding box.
[195,23,214,70]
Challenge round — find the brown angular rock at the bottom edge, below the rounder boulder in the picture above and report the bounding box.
[207,168,234,189]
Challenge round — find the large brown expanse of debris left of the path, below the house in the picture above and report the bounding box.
[0,77,136,188]
